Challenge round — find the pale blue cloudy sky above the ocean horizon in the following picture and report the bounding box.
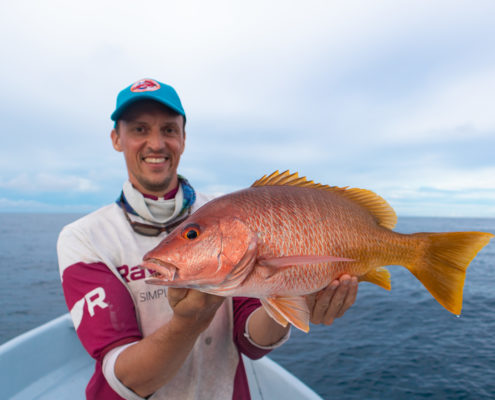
[0,0,495,218]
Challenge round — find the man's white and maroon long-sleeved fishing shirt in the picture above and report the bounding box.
[57,182,287,400]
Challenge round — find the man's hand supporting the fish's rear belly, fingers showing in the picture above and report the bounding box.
[306,275,358,325]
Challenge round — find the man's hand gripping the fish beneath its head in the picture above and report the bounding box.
[167,288,225,329]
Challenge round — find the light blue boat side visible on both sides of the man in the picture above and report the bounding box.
[0,314,321,400]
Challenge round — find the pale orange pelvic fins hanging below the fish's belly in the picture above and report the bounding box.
[261,296,310,333]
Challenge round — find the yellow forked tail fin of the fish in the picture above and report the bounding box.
[405,232,495,315]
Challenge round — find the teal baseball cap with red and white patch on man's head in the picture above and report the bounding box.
[110,79,186,121]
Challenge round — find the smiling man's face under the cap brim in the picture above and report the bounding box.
[111,101,186,197]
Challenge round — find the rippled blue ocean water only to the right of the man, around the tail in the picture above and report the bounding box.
[271,218,495,399]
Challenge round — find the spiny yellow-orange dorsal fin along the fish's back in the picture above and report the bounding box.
[251,171,397,229]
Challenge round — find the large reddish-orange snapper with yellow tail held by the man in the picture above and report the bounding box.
[142,171,494,332]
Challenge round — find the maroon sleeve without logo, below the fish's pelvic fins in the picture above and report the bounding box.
[233,297,271,360]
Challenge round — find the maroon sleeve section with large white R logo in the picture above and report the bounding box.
[62,263,142,362]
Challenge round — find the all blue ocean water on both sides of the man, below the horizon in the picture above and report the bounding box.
[0,214,495,400]
